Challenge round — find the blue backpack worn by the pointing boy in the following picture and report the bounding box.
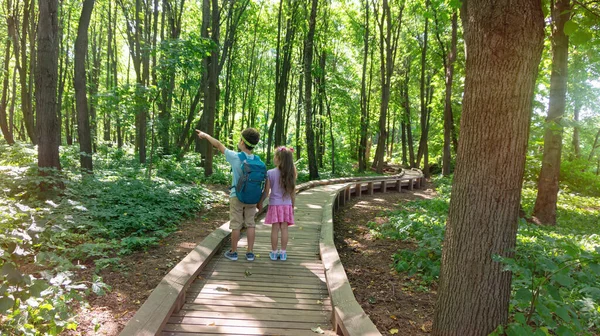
[235,152,267,204]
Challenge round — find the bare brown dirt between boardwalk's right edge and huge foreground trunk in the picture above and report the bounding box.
[334,184,436,335]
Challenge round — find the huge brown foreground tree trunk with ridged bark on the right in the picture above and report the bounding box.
[432,0,544,336]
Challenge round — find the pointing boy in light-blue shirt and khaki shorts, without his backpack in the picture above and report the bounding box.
[196,128,260,261]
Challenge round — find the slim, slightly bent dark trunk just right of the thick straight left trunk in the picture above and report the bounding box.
[73,0,95,173]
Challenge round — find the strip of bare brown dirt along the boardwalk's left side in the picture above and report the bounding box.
[66,186,229,336]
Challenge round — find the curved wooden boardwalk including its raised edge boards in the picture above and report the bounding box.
[121,170,423,336]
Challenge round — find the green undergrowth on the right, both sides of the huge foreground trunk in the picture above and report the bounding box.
[371,178,600,335]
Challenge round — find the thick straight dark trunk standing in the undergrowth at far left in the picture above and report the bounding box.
[35,0,60,174]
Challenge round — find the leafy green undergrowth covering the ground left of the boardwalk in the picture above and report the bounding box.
[0,145,223,335]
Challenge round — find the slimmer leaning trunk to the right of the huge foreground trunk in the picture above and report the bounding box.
[533,0,571,225]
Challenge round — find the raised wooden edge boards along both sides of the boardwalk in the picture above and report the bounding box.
[119,171,423,336]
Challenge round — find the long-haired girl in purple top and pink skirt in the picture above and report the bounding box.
[256,147,297,260]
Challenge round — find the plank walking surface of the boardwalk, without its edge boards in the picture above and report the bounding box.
[163,185,339,336]
